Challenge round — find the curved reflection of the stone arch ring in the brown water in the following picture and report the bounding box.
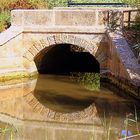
[24,94,97,123]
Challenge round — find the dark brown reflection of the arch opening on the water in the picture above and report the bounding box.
[33,75,98,113]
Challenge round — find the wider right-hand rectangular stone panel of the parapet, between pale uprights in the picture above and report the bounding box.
[55,10,96,26]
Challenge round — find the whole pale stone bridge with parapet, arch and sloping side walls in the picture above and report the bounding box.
[0,8,140,93]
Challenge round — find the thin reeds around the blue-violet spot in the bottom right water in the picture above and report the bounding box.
[101,105,140,140]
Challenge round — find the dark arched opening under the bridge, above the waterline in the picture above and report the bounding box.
[35,44,100,75]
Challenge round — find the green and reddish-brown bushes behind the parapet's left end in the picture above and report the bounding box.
[0,0,47,32]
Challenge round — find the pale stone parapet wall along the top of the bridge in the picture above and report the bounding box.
[12,9,108,27]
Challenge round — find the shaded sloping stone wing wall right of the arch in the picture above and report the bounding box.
[105,31,140,98]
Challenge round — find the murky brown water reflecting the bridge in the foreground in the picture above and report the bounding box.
[0,75,140,140]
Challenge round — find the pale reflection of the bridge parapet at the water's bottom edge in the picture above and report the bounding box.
[0,114,104,140]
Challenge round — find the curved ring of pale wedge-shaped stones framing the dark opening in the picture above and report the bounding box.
[23,34,100,72]
